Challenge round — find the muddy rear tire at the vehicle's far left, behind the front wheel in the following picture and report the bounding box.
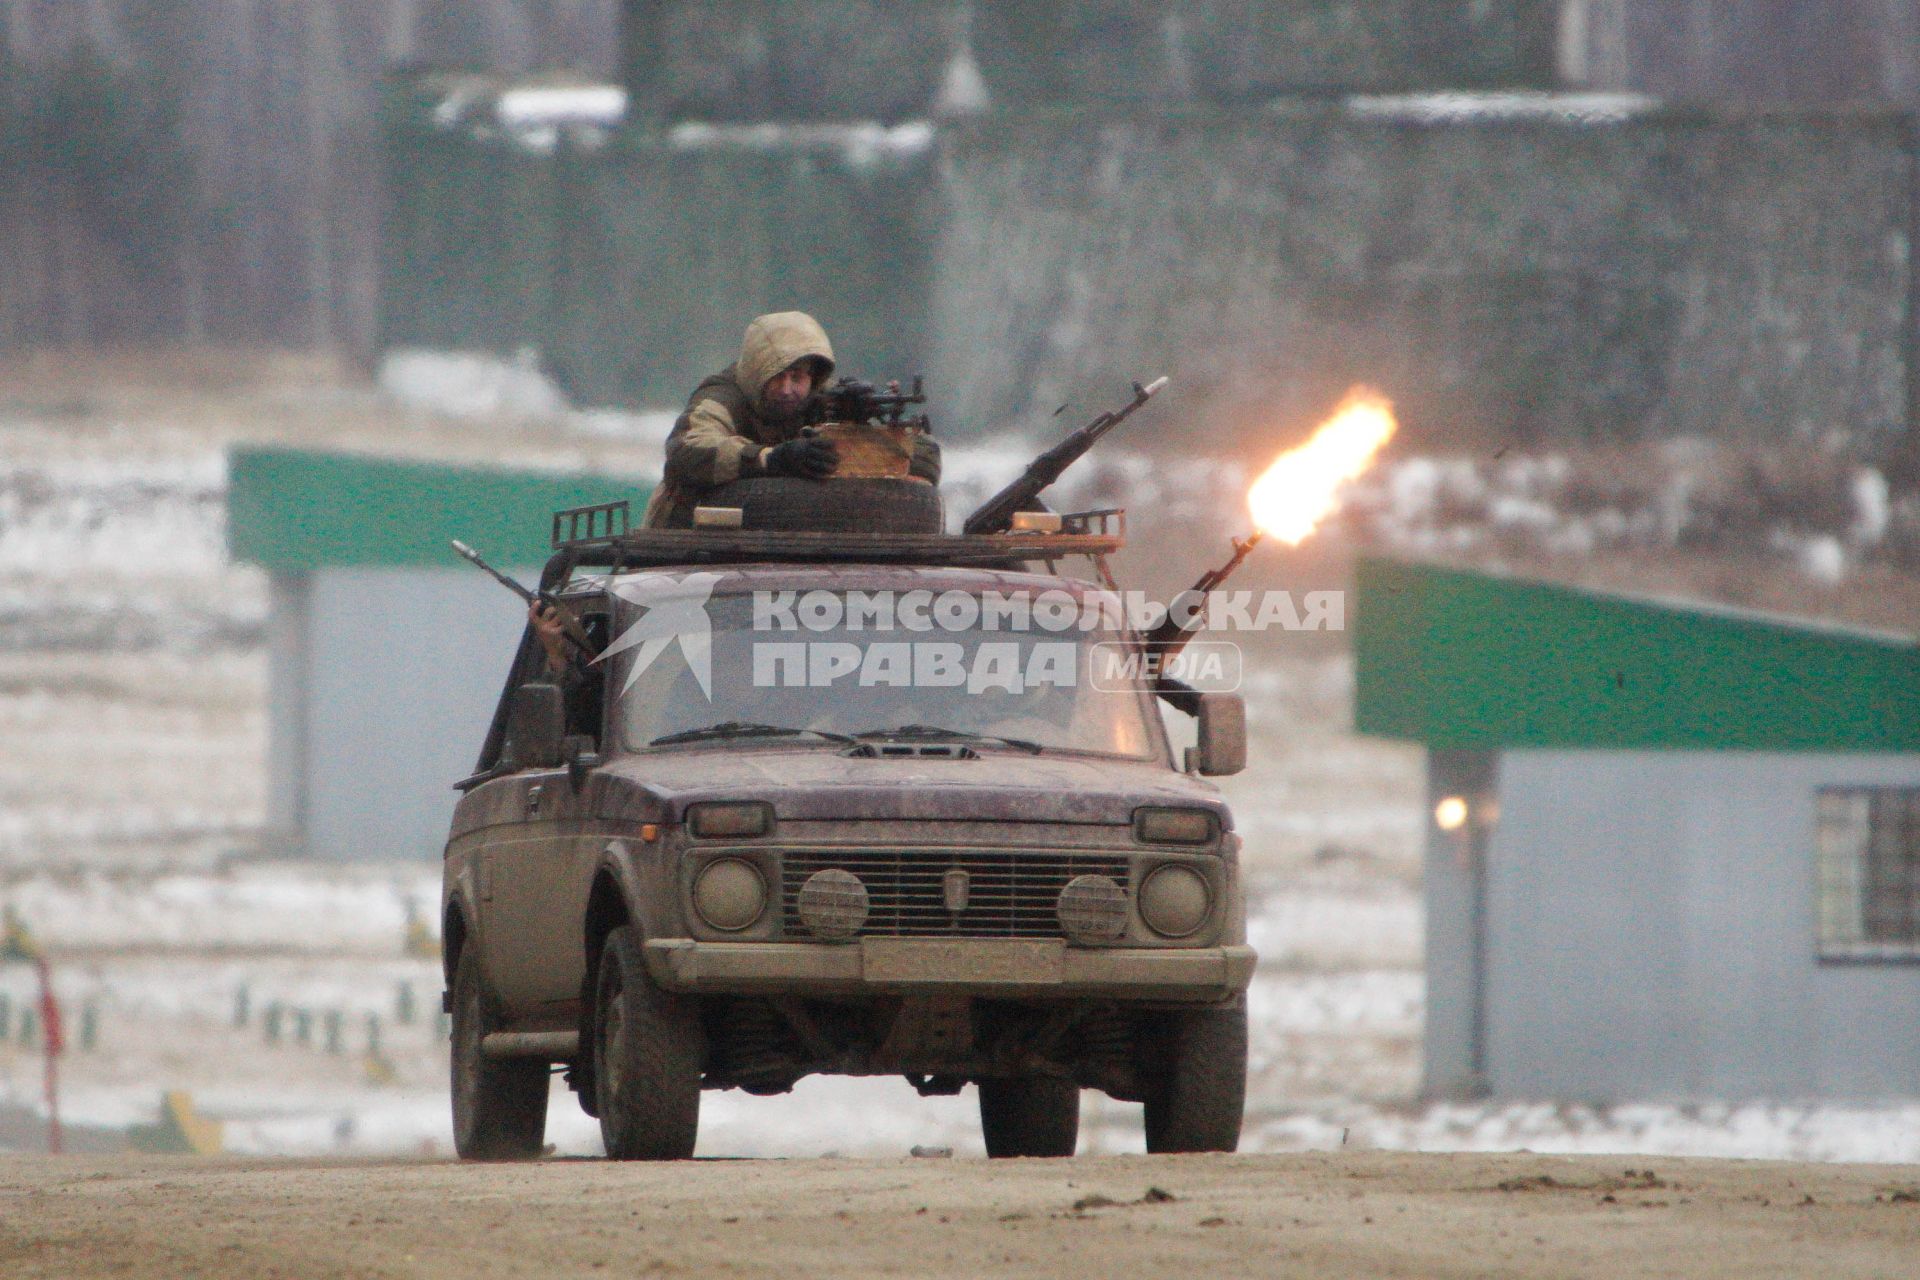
[451,946,549,1159]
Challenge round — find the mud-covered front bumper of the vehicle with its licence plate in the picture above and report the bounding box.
[645,938,1254,1002]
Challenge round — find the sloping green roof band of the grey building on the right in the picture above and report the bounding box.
[1350,560,1920,750]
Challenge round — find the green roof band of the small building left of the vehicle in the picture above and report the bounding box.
[227,449,651,570]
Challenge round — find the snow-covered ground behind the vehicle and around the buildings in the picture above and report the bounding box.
[0,355,1920,1161]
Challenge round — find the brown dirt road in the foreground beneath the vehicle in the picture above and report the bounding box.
[0,1153,1920,1280]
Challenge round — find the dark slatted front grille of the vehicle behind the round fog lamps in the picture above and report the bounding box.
[780,848,1131,938]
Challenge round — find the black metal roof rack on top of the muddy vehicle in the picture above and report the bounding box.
[553,503,1127,572]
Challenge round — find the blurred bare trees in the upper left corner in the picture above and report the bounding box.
[0,0,620,357]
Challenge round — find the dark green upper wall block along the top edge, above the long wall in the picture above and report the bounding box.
[622,0,1561,121]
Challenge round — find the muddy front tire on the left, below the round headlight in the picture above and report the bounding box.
[593,925,705,1159]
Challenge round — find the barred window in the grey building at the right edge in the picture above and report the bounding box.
[1814,787,1920,960]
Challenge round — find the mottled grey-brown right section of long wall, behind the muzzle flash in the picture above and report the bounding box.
[927,106,1920,461]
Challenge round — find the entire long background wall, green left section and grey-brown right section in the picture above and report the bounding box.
[386,81,1920,462]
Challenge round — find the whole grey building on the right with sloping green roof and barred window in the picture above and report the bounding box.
[1352,560,1920,1103]
